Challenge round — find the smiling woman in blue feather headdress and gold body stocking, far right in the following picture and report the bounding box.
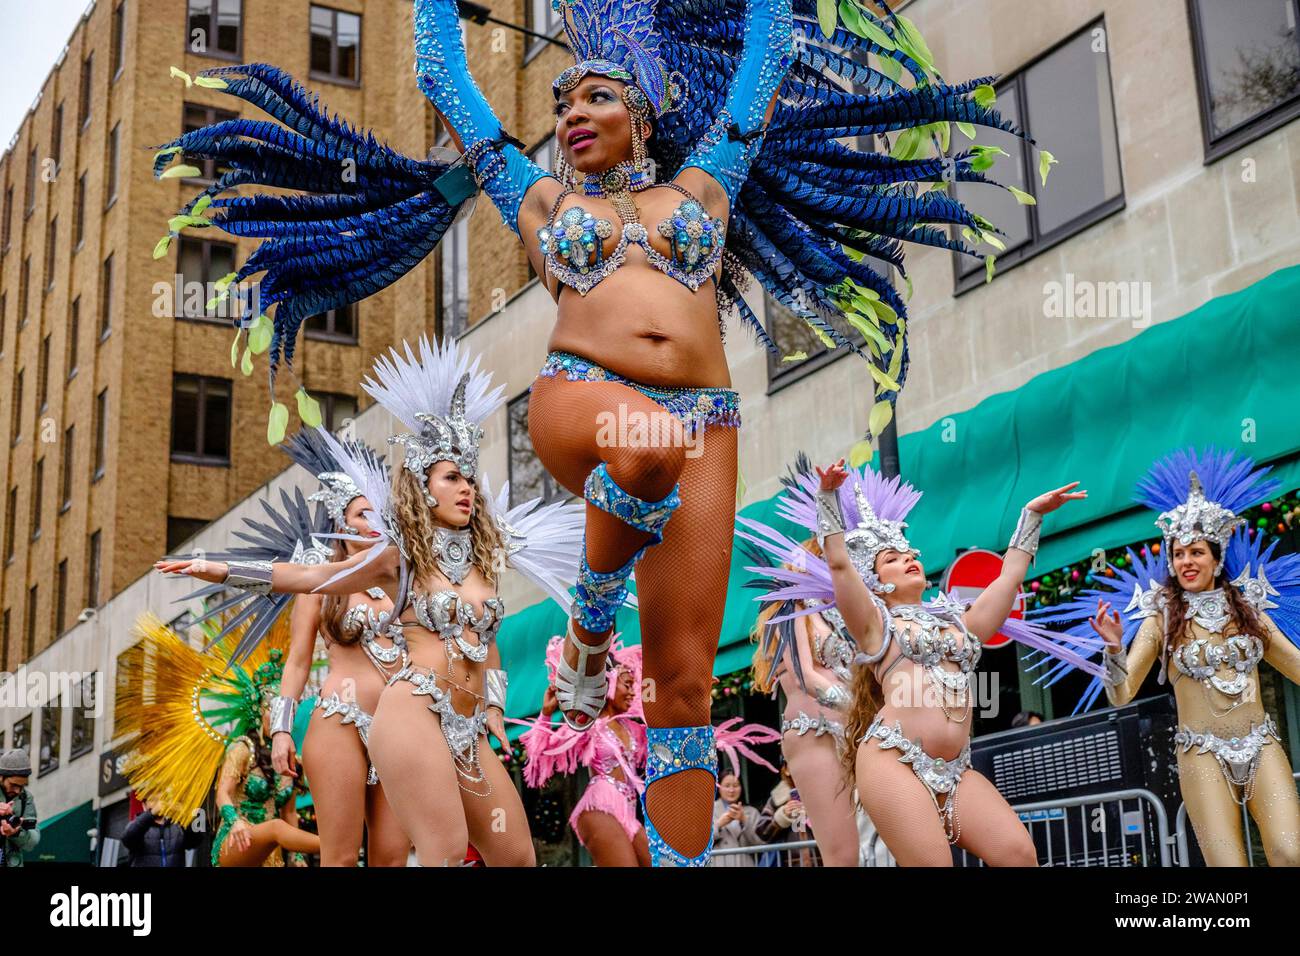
[1035,449,1300,866]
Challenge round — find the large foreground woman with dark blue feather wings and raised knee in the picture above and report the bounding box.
[149,0,1045,865]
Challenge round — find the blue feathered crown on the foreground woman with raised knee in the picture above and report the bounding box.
[551,0,686,117]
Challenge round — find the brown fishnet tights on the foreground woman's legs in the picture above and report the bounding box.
[528,375,736,856]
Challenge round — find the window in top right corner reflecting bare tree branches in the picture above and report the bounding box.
[1190,0,1300,161]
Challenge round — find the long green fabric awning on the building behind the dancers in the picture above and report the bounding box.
[501,267,1300,717]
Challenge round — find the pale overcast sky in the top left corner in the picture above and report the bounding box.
[0,0,90,152]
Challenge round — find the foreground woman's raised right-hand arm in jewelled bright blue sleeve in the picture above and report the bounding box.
[677,0,794,206]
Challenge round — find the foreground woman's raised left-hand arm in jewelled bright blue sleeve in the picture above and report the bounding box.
[415,0,559,234]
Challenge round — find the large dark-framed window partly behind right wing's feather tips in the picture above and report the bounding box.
[953,20,1125,291]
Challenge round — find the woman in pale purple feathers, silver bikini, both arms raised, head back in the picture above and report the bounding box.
[737,459,1100,866]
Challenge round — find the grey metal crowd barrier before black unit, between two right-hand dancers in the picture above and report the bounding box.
[867,788,1186,866]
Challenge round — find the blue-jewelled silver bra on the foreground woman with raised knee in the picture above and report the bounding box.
[537,182,727,295]
